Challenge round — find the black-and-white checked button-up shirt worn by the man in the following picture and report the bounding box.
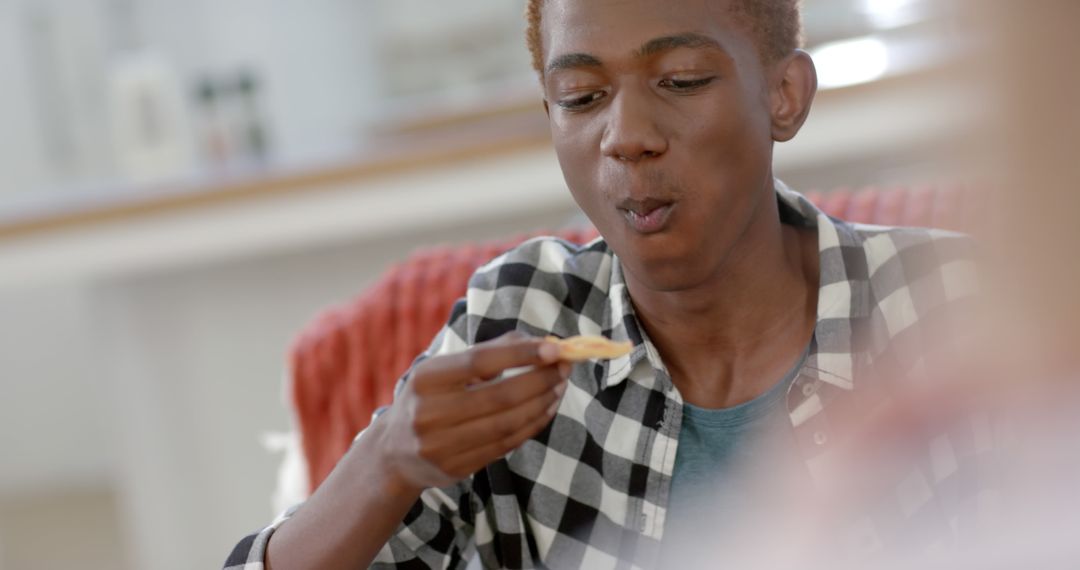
[227,182,985,569]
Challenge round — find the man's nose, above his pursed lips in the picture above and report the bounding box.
[600,89,667,162]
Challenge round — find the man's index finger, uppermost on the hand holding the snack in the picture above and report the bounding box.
[413,333,558,390]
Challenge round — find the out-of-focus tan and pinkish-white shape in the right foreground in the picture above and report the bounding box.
[734,0,1080,569]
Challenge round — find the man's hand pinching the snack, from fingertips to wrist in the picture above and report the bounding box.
[378,333,570,493]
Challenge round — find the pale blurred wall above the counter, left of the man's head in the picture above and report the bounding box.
[0,0,528,200]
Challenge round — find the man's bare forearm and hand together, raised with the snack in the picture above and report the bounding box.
[266,333,570,570]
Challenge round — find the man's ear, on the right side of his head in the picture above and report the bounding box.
[769,50,818,143]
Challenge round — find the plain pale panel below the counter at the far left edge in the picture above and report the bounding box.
[0,284,114,494]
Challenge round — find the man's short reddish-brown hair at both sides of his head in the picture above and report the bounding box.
[525,0,802,74]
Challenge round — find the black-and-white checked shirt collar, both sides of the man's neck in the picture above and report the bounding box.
[596,180,868,390]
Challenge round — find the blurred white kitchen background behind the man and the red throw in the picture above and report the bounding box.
[0,0,986,570]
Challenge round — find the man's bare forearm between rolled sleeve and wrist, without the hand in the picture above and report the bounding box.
[266,422,420,570]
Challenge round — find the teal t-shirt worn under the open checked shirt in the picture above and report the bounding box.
[664,347,810,555]
